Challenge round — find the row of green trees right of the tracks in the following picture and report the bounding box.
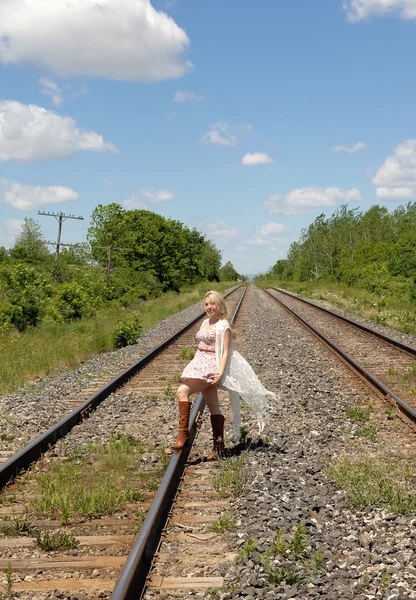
[262,202,416,300]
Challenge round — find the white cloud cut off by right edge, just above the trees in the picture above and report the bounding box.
[372,139,416,188]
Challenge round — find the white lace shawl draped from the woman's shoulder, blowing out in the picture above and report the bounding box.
[208,319,278,442]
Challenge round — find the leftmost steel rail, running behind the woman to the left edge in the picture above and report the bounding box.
[0,285,240,490]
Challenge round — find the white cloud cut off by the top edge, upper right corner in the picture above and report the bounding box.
[343,0,416,22]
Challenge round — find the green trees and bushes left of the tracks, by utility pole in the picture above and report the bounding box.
[0,204,239,335]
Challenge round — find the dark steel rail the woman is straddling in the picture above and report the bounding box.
[111,288,247,600]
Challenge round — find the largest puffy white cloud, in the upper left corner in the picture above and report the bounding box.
[0,0,192,81]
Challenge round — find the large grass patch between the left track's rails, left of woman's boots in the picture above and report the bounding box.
[27,435,166,523]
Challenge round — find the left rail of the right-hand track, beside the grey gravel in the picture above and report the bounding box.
[264,289,416,424]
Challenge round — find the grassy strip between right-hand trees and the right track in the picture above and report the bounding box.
[256,281,416,335]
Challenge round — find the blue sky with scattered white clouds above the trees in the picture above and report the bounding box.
[0,0,416,273]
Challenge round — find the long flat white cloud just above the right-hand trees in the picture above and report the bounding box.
[263,186,362,215]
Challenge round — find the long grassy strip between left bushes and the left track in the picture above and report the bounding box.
[0,282,235,394]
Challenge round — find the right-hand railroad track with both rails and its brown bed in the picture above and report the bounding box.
[265,288,416,428]
